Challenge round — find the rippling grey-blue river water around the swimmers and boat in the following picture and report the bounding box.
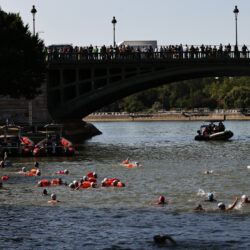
[0,121,250,249]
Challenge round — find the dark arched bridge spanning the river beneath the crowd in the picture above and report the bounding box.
[47,51,250,120]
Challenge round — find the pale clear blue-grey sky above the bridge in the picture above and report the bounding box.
[0,0,250,46]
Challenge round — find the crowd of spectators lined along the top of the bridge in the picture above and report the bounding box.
[45,44,248,61]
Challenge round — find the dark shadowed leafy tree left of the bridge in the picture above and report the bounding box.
[0,9,46,99]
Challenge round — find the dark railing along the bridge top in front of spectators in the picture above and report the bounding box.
[46,51,250,63]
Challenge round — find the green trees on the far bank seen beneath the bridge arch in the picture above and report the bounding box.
[100,77,250,112]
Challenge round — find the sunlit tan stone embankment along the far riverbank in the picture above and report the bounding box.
[83,110,250,122]
